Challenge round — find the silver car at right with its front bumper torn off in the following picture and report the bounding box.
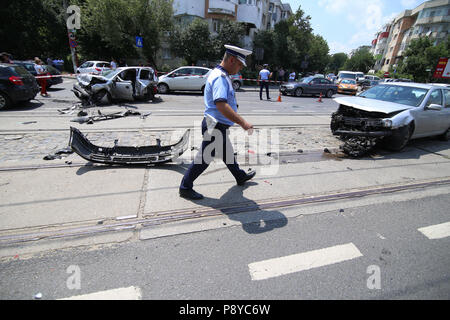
[331,83,450,157]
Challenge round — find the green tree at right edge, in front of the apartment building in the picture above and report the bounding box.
[399,37,449,82]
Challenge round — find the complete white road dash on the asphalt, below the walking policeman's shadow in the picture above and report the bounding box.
[248,243,362,280]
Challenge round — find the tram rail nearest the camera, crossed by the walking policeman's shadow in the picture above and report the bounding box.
[0,177,450,247]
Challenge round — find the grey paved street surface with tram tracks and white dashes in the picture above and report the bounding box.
[0,79,450,299]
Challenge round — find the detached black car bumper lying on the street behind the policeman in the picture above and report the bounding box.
[69,127,190,164]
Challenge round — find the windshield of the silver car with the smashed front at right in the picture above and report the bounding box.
[359,84,428,107]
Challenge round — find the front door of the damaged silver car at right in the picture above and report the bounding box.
[412,89,446,137]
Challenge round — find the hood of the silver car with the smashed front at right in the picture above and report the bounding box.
[333,97,414,113]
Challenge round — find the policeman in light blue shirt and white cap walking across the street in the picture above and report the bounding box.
[179,45,256,200]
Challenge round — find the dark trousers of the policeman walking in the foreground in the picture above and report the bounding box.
[180,119,246,189]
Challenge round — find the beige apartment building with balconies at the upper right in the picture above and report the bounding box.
[371,0,450,71]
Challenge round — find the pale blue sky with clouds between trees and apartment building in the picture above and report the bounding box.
[281,0,425,54]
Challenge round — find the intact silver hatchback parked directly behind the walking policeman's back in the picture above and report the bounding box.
[158,67,211,94]
